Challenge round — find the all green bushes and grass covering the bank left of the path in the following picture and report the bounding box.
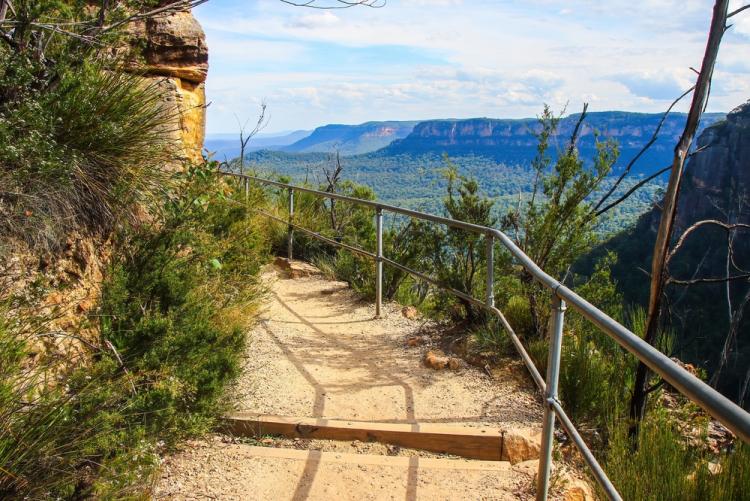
[0,0,270,499]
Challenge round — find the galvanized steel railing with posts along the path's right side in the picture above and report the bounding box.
[222,172,750,500]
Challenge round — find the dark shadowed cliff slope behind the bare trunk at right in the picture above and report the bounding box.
[594,101,750,399]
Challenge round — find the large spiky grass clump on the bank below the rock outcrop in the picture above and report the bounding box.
[0,63,175,249]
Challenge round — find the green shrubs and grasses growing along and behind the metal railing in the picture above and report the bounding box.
[256,103,750,500]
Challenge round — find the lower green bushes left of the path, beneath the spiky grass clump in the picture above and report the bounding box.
[0,165,269,498]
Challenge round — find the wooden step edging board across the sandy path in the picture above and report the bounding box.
[225,413,524,461]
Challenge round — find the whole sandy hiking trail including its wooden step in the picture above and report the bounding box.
[154,262,564,500]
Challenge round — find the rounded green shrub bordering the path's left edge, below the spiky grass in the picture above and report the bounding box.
[101,162,268,437]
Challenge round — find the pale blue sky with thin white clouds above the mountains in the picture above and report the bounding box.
[194,0,750,134]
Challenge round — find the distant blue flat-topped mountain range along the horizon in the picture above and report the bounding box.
[212,111,725,174]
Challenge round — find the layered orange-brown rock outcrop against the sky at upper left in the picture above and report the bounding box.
[130,6,208,162]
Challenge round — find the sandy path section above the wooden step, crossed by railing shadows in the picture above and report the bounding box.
[232,272,542,427]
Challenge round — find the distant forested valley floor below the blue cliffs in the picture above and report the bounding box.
[241,151,664,235]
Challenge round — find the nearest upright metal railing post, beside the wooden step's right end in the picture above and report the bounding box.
[536,294,565,501]
